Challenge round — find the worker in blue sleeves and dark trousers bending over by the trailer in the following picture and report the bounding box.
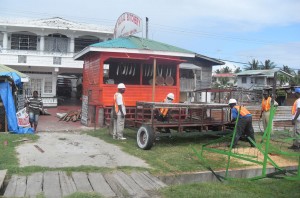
[228,99,255,148]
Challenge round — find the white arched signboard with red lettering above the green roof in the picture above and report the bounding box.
[114,12,143,38]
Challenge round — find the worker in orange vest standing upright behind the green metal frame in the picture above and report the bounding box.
[260,91,278,134]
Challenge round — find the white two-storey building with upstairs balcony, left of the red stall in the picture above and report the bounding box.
[0,17,113,106]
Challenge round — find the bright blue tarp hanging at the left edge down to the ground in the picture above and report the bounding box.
[0,82,33,134]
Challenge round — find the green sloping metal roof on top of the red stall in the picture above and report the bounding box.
[90,36,196,54]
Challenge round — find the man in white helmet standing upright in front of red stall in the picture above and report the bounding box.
[113,83,126,140]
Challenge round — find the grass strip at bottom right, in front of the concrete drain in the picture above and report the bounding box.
[160,179,300,198]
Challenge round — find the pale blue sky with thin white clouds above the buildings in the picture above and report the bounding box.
[0,0,300,70]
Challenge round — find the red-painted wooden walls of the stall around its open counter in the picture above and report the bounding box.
[83,52,181,106]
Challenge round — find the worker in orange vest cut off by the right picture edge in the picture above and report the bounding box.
[288,87,300,151]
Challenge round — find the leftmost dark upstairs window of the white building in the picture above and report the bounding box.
[11,34,37,50]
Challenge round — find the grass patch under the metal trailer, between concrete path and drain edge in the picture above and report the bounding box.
[88,129,253,174]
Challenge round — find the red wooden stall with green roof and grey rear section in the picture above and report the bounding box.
[75,36,224,126]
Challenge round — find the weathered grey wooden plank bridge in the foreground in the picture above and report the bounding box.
[0,171,167,198]
